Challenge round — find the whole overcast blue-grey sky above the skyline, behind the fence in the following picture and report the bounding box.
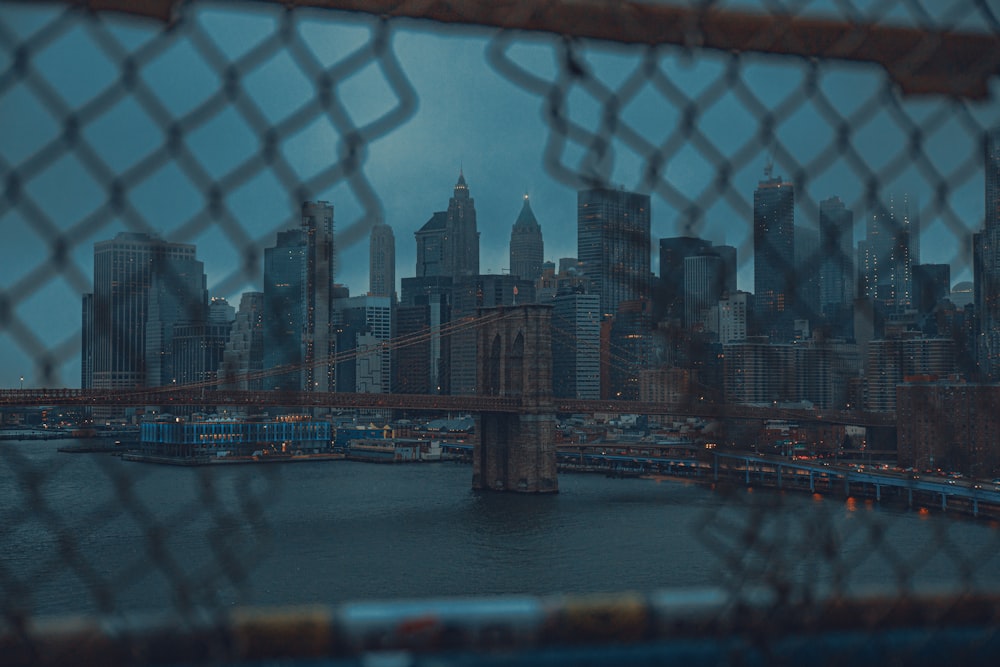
[0,4,1000,387]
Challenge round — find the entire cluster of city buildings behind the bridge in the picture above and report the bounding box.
[82,130,1000,436]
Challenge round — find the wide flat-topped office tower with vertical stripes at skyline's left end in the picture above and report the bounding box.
[88,232,207,389]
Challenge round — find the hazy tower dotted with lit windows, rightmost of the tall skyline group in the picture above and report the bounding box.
[858,194,919,314]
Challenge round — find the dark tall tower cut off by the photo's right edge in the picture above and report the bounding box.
[972,127,1000,382]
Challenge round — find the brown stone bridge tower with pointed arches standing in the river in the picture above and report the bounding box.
[472,304,559,493]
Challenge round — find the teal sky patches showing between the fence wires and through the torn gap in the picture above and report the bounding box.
[0,6,992,386]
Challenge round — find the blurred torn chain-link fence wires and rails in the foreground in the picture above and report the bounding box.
[0,0,1000,665]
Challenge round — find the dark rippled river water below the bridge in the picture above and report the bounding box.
[0,441,1000,614]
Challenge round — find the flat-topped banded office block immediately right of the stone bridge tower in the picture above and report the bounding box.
[551,293,601,399]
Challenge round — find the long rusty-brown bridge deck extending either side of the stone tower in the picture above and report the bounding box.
[0,387,896,427]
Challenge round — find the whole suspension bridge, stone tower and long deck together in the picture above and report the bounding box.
[0,304,895,493]
